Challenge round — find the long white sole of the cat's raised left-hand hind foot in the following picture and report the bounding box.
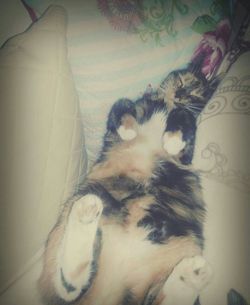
[55,194,103,304]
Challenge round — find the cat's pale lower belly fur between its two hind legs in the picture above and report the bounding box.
[80,221,200,305]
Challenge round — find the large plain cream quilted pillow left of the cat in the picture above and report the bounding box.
[0,7,87,286]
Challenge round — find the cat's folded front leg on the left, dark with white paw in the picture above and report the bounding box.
[107,99,137,141]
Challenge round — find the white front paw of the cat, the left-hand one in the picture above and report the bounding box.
[117,114,137,141]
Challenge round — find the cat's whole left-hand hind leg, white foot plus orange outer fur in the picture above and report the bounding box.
[40,194,103,303]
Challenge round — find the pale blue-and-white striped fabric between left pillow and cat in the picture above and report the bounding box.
[23,0,223,165]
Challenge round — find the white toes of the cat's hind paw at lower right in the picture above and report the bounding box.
[174,255,213,291]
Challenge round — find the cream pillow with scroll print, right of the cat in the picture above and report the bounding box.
[194,52,250,191]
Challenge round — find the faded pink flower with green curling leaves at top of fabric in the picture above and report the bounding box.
[98,0,189,42]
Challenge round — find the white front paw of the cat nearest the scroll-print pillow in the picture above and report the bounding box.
[163,131,186,156]
